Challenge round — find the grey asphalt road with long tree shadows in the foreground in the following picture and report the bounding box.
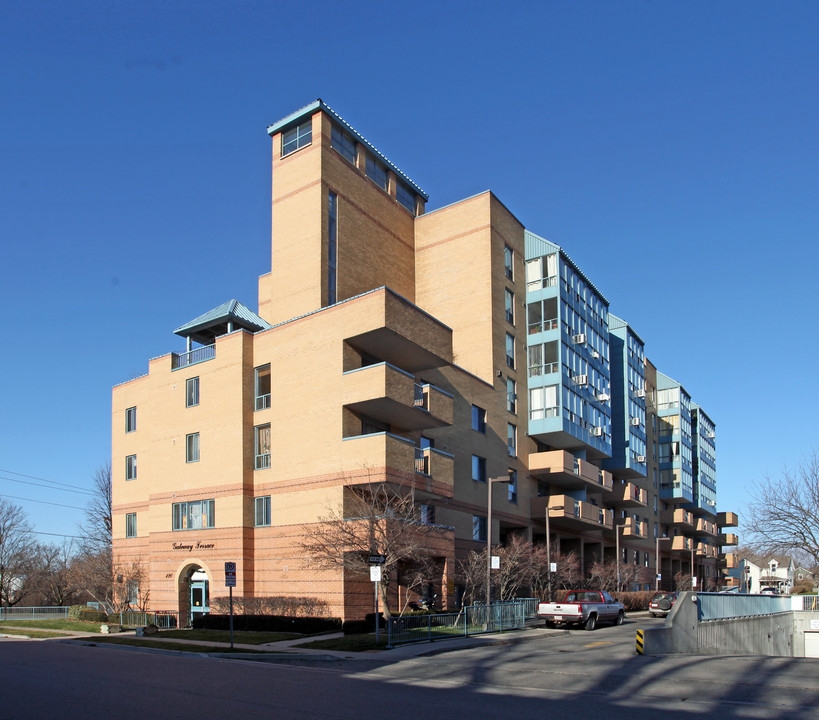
[0,618,819,720]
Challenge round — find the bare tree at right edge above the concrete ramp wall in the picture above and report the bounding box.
[745,450,819,565]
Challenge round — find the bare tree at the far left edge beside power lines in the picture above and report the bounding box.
[0,498,37,607]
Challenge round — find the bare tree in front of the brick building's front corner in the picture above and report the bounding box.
[300,483,444,617]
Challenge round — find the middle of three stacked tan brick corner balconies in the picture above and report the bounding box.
[341,362,452,430]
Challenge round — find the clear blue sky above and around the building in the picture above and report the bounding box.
[0,0,819,541]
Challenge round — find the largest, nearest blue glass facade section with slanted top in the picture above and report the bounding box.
[525,231,611,456]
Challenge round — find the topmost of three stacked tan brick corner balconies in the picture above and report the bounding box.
[343,288,452,373]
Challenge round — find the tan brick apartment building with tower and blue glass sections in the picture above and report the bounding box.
[112,100,736,618]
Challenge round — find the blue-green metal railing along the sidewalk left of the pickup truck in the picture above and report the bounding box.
[387,598,539,646]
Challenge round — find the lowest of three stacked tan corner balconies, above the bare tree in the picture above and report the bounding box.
[341,432,455,497]
